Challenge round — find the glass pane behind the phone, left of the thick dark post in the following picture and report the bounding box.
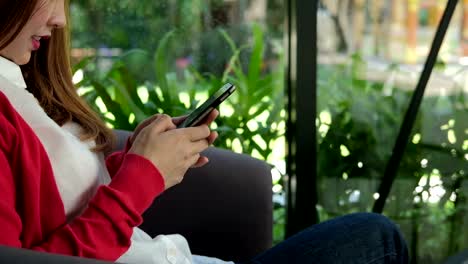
[71,0,286,243]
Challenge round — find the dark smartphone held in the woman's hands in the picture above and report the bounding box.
[177,83,236,128]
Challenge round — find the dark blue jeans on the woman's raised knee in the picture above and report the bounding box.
[243,213,408,264]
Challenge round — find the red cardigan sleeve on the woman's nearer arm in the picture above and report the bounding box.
[31,154,164,261]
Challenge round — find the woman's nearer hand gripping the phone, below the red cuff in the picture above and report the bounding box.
[129,115,211,189]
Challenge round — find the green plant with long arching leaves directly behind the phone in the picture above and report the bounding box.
[75,26,284,160]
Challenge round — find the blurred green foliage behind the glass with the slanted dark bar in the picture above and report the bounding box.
[317,55,468,263]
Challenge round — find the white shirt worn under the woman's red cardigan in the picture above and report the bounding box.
[0,56,232,264]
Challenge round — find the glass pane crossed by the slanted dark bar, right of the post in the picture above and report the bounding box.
[317,0,468,263]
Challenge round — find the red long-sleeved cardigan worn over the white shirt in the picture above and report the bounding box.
[0,92,164,261]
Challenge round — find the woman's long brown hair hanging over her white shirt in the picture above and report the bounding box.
[0,0,114,152]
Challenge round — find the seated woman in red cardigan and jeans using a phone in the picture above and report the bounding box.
[0,0,407,263]
